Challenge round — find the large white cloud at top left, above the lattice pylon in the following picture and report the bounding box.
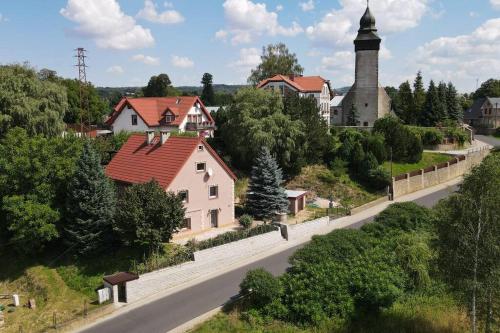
[60,0,154,50]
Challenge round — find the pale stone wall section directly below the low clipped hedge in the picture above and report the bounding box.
[194,230,283,261]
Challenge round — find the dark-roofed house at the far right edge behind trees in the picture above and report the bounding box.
[464,97,500,129]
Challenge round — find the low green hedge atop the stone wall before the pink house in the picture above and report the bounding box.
[186,224,279,251]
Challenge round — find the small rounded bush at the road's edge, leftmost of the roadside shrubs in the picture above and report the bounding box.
[240,268,283,308]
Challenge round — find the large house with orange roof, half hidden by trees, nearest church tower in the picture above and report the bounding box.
[257,75,334,124]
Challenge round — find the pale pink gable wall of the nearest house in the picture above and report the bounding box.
[167,141,235,237]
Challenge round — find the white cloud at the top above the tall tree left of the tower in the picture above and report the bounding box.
[216,0,304,44]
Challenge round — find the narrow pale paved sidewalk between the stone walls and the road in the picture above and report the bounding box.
[78,178,462,332]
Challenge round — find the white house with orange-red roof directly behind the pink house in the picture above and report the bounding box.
[106,96,215,137]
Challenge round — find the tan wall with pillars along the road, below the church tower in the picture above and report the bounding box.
[392,147,490,198]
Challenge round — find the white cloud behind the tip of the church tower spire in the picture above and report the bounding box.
[306,0,430,46]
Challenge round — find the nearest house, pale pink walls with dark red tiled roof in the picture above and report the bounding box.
[106,131,236,238]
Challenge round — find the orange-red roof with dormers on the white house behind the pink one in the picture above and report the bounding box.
[106,96,214,127]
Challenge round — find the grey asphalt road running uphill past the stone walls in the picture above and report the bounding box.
[84,186,457,333]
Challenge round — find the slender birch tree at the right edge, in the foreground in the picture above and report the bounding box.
[437,153,500,333]
